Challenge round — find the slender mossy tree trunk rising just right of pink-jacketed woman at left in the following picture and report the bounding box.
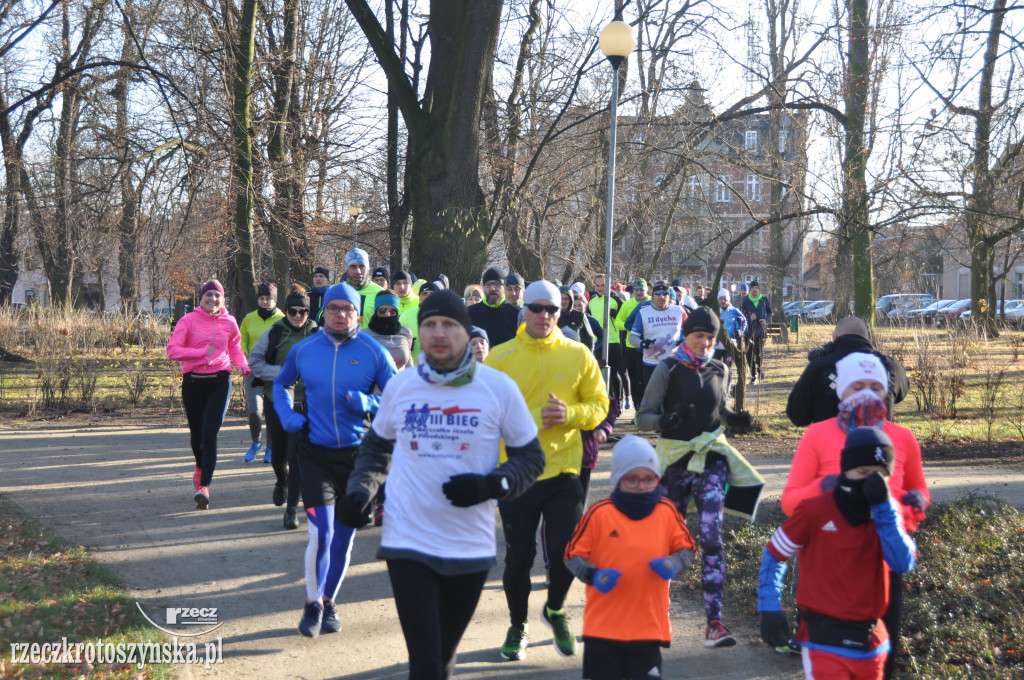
[231,0,257,309]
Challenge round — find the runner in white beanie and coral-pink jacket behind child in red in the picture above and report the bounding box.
[781,352,932,679]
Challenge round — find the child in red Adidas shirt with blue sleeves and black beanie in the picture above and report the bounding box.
[758,427,914,680]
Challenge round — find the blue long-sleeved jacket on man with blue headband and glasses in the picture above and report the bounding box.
[273,331,398,449]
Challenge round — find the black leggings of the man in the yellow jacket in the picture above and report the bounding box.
[498,474,583,626]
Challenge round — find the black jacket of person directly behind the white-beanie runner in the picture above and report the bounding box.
[785,335,910,427]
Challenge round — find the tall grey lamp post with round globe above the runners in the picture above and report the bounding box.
[597,15,637,394]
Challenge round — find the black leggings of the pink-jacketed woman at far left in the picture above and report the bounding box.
[181,371,231,486]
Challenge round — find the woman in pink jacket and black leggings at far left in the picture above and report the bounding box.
[167,279,250,510]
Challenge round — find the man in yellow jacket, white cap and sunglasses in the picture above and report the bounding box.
[484,281,608,661]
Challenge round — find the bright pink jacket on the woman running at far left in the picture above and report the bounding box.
[167,307,249,375]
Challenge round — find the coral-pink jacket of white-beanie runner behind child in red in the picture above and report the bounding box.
[781,418,932,532]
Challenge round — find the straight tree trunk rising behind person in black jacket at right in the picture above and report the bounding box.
[840,0,874,329]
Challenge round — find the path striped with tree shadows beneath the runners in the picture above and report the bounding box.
[0,418,1024,680]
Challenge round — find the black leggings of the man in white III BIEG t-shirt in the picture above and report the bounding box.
[387,559,487,680]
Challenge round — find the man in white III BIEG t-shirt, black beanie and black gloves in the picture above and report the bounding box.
[339,291,544,678]
